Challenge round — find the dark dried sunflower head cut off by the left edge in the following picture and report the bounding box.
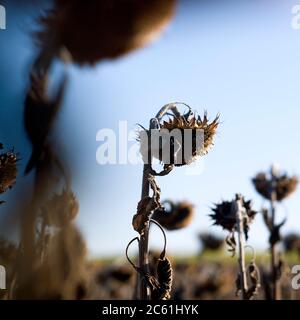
[0,151,18,193]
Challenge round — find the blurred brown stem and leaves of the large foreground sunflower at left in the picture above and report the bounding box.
[8,24,86,299]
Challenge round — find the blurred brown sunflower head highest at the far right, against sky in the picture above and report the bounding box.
[252,172,298,201]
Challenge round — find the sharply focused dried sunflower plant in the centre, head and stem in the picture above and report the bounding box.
[127,103,219,299]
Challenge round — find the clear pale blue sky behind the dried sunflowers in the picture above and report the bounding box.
[0,0,300,255]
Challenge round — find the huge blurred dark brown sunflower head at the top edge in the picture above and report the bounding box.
[38,0,176,64]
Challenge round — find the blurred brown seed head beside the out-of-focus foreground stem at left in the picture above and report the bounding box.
[41,190,79,227]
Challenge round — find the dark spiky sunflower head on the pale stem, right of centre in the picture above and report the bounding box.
[209,197,257,238]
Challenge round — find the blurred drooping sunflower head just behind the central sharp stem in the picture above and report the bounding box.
[152,200,194,230]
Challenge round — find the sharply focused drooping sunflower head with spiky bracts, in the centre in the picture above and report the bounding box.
[139,110,219,166]
